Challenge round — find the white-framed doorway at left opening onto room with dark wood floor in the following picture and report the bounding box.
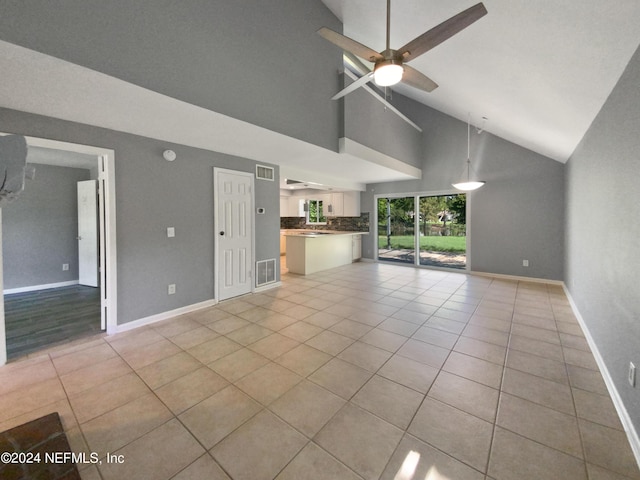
[0,137,117,365]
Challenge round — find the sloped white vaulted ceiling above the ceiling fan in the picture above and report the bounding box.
[322,0,640,162]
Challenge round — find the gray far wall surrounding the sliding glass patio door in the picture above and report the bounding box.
[361,95,564,280]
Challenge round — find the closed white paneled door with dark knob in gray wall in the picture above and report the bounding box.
[214,169,253,300]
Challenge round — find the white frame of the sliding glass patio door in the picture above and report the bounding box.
[372,189,471,273]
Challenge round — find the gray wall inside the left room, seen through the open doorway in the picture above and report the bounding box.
[2,165,90,289]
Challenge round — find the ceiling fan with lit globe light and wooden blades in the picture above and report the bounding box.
[318,0,487,100]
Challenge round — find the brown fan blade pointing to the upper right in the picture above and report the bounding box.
[398,3,487,62]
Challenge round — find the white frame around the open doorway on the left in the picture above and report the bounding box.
[0,133,118,365]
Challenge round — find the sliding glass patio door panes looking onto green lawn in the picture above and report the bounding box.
[376,193,467,270]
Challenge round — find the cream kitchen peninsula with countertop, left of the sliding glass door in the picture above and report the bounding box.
[282,230,368,275]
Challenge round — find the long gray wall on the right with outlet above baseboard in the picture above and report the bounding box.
[566,43,640,431]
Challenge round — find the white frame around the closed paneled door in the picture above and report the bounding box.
[213,167,256,303]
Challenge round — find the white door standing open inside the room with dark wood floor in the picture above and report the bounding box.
[78,180,99,287]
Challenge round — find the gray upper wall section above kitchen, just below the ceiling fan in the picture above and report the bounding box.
[342,79,423,168]
